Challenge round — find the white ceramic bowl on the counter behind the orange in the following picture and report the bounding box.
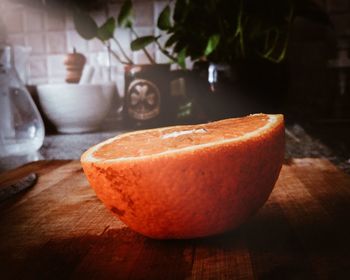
[38,83,116,133]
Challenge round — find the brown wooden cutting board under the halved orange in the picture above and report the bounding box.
[0,159,350,279]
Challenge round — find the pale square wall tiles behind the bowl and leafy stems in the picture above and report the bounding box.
[0,0,168,84]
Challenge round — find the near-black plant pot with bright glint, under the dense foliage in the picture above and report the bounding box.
[187,61,288,121]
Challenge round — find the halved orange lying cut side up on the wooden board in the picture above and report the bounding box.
[81,114,284,238]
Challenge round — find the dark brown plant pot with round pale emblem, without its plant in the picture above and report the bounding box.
[123,64,194,129]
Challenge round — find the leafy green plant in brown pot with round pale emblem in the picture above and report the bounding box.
[74,0,196,128]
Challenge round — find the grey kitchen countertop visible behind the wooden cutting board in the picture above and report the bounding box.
[0,124,350,173]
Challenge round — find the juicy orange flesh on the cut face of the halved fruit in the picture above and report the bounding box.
[93,112,268,159]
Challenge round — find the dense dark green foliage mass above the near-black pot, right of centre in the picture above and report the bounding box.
[165,0,329,63]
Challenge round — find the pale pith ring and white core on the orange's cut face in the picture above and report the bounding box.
[82,114,279,163]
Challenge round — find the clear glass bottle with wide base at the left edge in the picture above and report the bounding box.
[0,44,45,157]
